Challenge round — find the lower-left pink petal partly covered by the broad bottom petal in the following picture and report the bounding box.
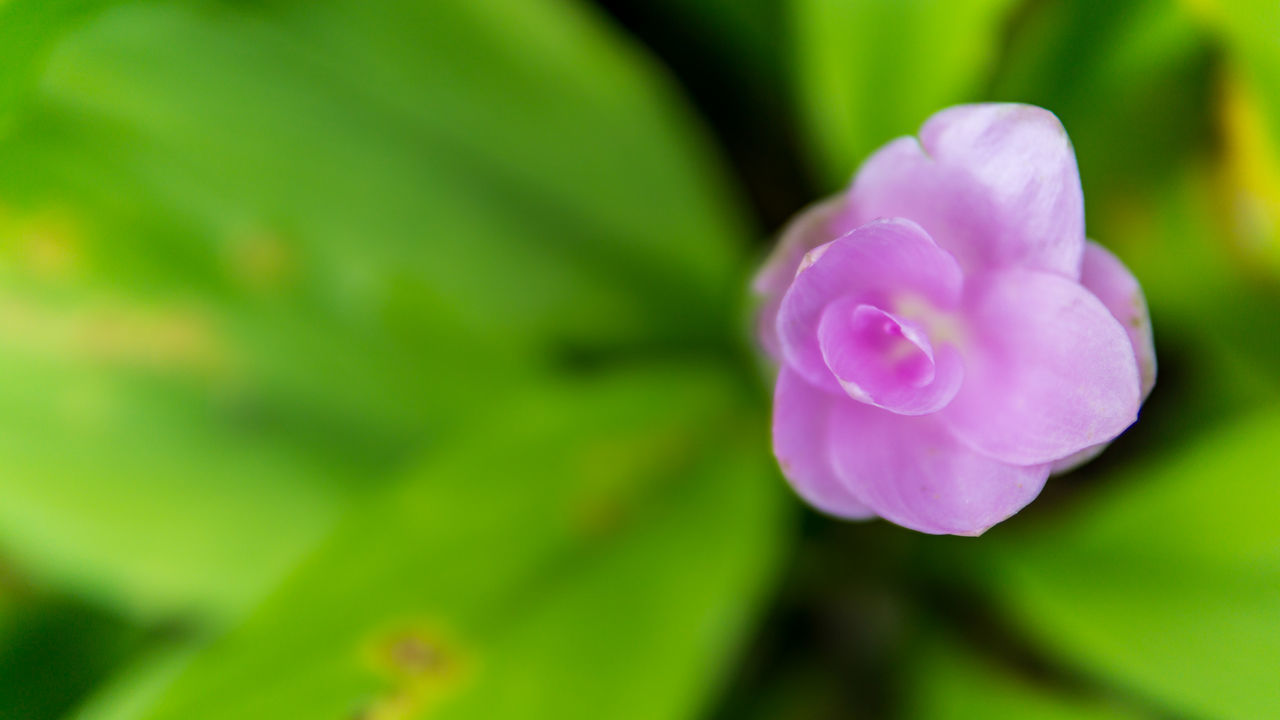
[773,368,874,519]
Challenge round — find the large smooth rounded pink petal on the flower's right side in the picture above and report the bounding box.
[940,270,1139,465]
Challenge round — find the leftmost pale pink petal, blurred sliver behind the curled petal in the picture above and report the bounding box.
[751,195,852,360]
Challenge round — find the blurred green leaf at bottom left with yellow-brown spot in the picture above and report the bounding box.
[115,369,782,720]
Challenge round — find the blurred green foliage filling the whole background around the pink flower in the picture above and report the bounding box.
[0,0,1280,720]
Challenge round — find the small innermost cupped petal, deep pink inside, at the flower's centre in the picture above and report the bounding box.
[818,297,964,415]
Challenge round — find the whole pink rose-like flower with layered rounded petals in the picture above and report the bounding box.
[755,105,1156,534]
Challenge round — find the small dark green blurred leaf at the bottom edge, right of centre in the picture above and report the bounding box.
[902,630,1152,720]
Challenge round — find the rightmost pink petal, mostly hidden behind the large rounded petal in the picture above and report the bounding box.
[1053,242,1156,473]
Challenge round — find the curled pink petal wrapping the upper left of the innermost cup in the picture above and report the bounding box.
[777,219,963,392]
